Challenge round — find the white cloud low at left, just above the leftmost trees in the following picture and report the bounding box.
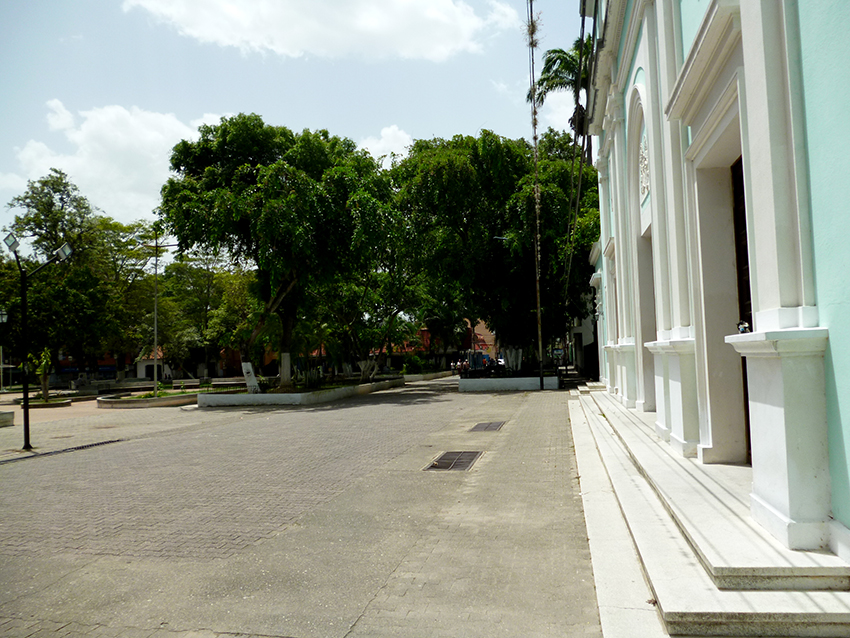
[0,99,219,228]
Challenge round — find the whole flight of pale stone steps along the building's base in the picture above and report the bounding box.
[570,388,850,638]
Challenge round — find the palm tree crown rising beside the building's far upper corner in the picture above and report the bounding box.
[526,36,593,160]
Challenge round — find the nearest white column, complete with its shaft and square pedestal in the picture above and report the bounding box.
[726,0,831,549]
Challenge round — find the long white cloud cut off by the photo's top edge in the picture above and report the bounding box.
[123,0,521,62]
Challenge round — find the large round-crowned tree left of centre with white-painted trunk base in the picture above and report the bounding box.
[160,114,376,383]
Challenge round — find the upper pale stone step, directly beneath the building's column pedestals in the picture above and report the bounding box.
[587,392,850,591]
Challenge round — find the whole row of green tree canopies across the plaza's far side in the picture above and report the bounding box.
[0,114,599,384]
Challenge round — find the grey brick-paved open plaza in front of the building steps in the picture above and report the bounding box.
[0,377,602,638]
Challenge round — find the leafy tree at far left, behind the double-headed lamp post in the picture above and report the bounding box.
[4,169,151,380]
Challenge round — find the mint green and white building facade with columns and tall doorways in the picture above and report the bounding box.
[584,0,850,560]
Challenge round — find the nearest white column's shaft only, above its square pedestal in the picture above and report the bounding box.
[741,0,817,331]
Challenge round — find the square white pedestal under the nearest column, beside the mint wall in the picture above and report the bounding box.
[726,328,830,549]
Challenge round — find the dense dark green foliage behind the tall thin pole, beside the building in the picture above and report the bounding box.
[394,129,598,364]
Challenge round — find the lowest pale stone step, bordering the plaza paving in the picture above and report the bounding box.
[579,396,850,637]
